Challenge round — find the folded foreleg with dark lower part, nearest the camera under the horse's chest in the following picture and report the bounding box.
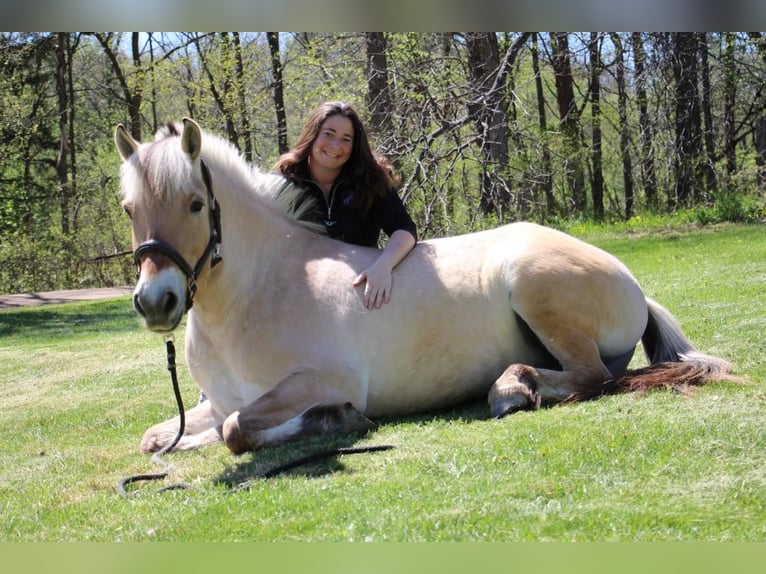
[223,372,376,454]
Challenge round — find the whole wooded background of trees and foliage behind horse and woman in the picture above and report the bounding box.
[0,32,766,293]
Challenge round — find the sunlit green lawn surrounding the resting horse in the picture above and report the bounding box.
[0,225,766,541]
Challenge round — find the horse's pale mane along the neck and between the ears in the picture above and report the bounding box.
[154,122,326,234]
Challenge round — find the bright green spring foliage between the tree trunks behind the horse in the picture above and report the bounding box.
[0,32,766,292]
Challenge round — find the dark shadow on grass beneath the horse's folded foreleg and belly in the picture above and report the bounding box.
[213,399,489,491]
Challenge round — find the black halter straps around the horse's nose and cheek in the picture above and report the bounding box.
[133,160,223,311]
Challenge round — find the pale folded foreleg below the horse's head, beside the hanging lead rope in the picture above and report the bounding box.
[141,401,223,453]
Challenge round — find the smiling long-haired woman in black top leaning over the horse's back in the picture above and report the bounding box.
[275,102,417,309]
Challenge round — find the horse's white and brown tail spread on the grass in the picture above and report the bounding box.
[604,297,740,393]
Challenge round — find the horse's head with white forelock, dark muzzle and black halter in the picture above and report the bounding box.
[114,118,220,332]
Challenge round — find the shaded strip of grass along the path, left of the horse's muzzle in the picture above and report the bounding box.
[0,298,141,338]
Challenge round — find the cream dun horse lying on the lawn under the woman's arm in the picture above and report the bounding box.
[114,118,731,460]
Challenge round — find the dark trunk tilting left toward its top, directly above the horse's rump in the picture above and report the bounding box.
[551,32,586,214]
